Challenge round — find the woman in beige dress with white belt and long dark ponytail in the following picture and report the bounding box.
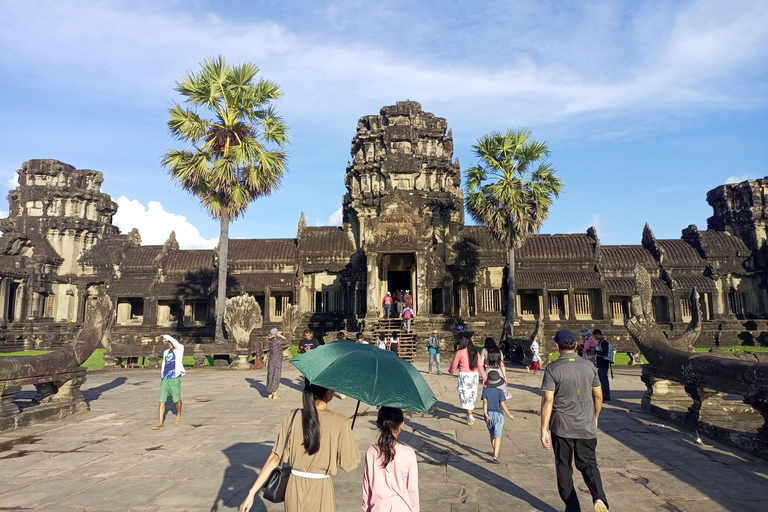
[240,379,360,512]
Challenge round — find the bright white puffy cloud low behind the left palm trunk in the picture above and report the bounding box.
[112,196,219,249]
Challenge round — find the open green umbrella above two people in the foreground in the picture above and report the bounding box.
[291,340,437,412]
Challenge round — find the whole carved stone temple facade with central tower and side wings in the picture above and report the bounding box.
[0,101,768,350]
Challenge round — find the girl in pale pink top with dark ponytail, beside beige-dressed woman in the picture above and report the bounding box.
[363,407,420,512]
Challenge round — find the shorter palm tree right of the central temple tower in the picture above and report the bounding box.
[465,129,563,340]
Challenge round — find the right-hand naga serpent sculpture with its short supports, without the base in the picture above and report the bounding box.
[627,266,768,440]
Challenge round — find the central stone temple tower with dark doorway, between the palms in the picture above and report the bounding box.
[343,101,464,317]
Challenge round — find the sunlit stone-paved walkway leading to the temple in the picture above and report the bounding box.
[0,364,768,512]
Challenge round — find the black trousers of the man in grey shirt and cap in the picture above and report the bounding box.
[552,434,608,512]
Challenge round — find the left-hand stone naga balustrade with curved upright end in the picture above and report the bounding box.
[0,296,112,431]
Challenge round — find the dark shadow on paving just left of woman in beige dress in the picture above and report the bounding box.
[211,443,272,512]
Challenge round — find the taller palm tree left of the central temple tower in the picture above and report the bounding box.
[162,56,288,343]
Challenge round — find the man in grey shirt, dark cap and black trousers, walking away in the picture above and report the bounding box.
[541,329,608,512]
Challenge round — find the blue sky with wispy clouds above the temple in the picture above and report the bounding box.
[0,0,768,247]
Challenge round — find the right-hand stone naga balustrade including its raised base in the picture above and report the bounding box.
[627,267,768,458]
